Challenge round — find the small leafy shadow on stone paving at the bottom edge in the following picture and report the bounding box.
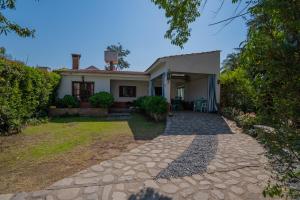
[128,188,172,200]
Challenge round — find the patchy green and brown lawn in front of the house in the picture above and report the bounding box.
[0,114,164,193]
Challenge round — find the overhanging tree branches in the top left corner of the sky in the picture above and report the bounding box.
[0,0,35,37]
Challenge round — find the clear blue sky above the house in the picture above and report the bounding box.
[0,0,246,71]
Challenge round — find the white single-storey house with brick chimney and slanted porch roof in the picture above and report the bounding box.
[58,51,220,111]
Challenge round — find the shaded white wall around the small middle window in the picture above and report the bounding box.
[110,80,148,102]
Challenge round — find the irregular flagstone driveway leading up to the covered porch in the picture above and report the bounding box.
[0,113,276,200]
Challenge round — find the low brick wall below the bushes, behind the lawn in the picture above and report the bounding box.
[49,108,108,117]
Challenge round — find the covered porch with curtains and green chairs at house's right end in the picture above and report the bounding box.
[149,71,218,112]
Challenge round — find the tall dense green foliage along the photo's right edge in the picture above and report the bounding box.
[241,0,300,197]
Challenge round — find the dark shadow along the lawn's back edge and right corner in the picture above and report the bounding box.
[50,113,165,140]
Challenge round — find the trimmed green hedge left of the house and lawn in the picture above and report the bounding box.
[0,58,60,135]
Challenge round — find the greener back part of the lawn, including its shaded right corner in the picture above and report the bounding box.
[0,114,164,166]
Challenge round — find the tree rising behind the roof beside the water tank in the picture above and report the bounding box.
[106,43,130,70]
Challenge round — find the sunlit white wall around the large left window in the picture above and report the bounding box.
[58,75,110,98]
